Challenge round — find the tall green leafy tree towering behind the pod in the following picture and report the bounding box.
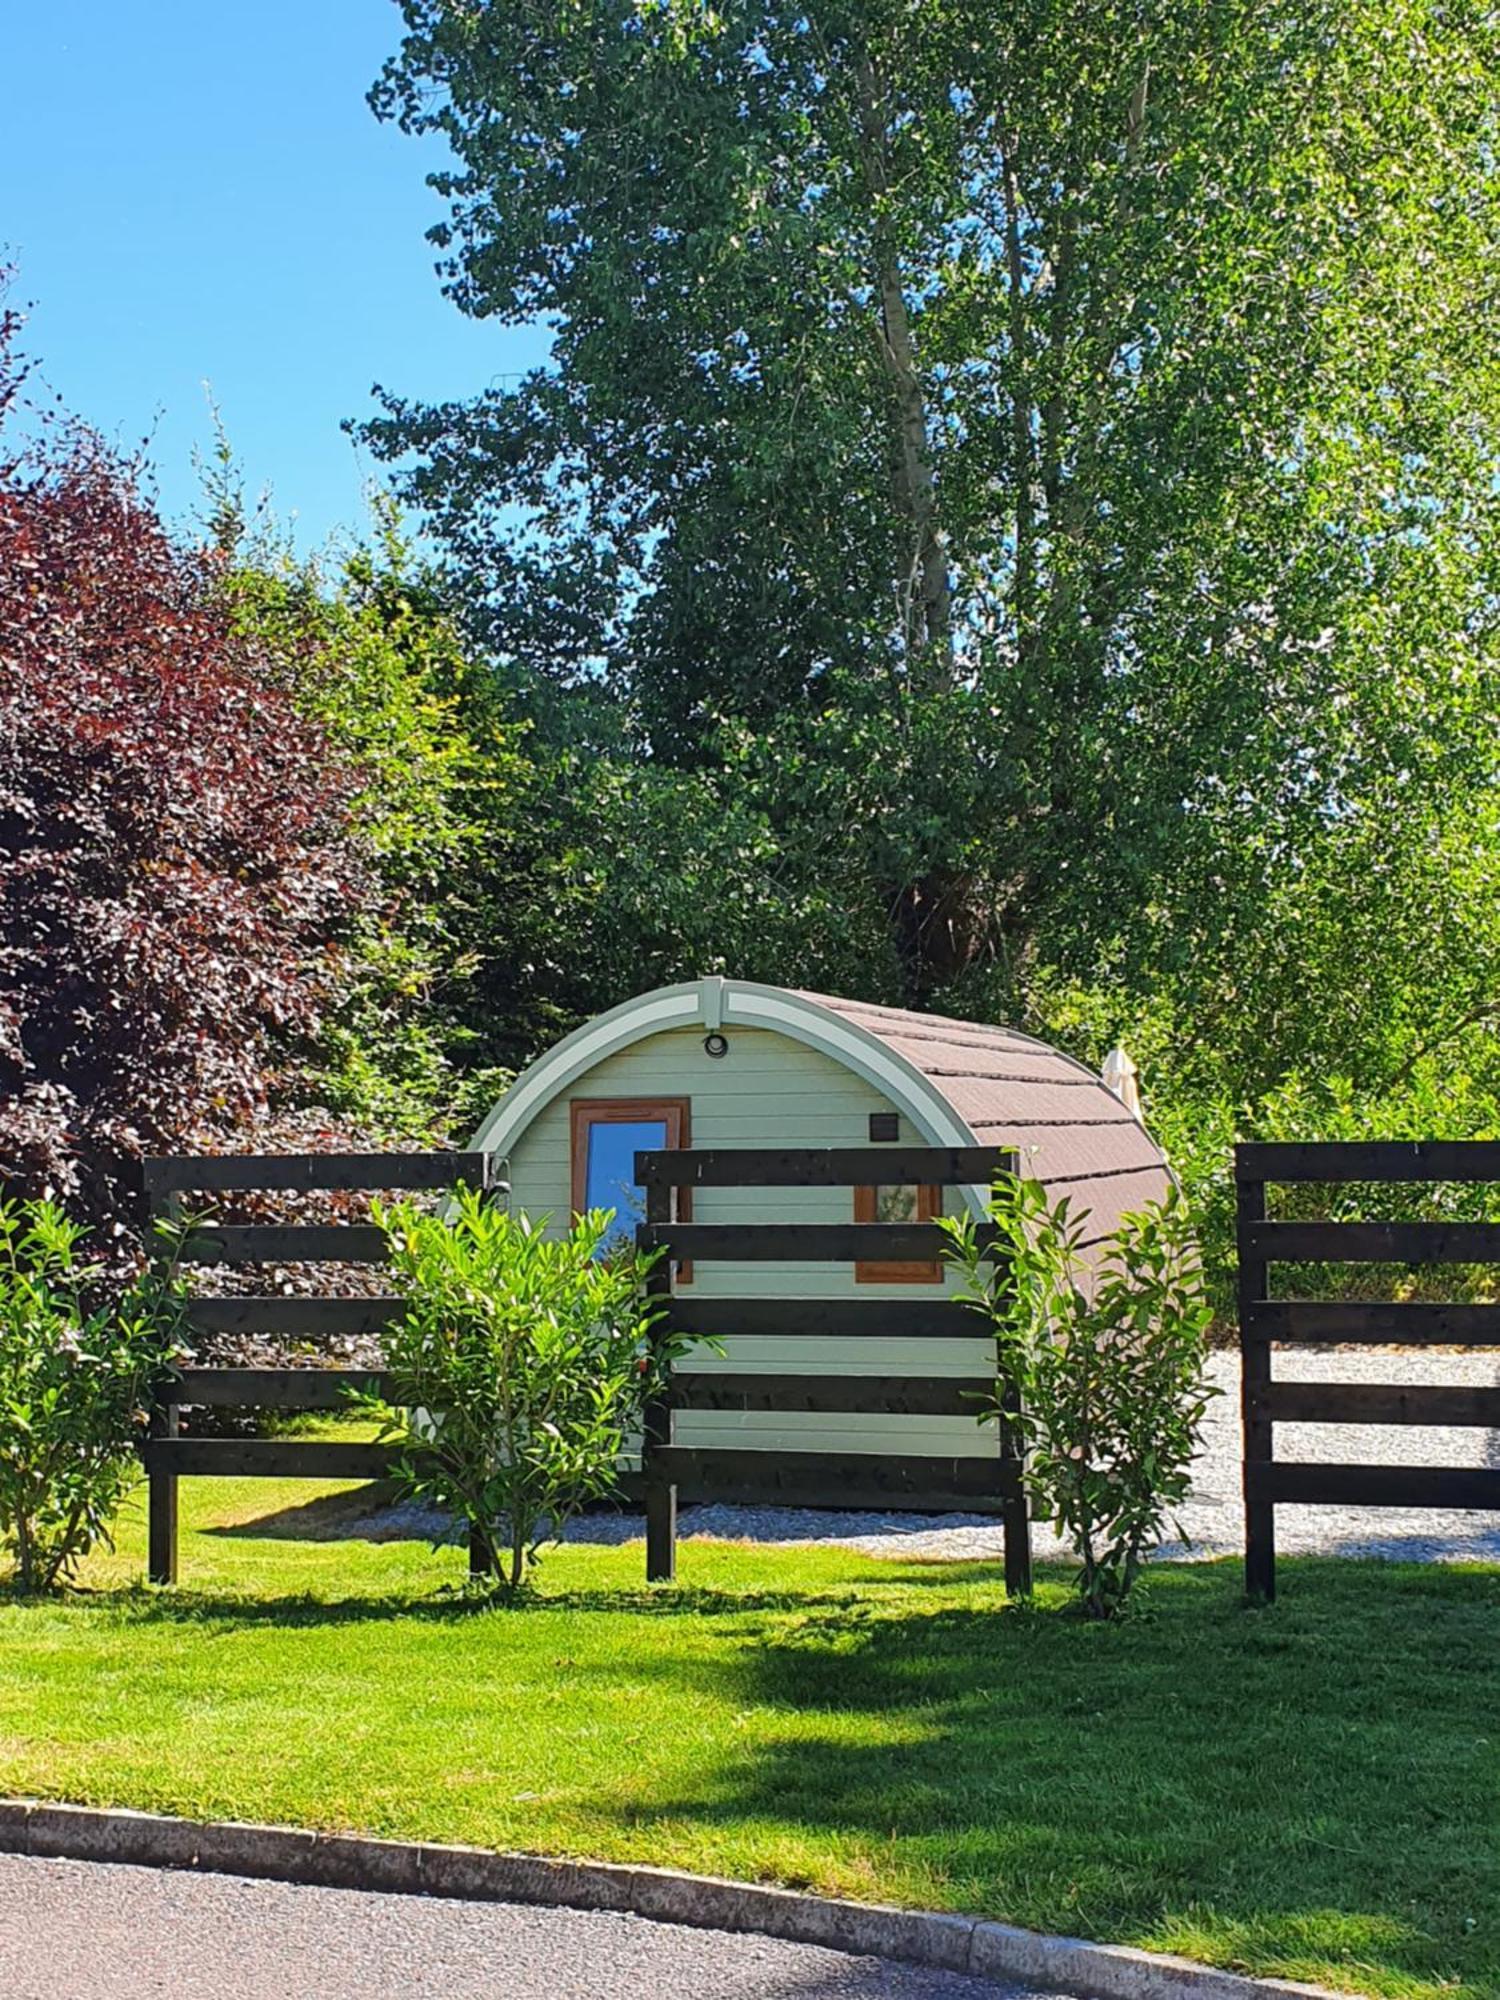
[366,0,1500,1004]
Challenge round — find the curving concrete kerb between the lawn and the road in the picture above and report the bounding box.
[0,1800,1348,2000]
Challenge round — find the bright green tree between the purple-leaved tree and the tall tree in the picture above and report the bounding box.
[208,484,582,1142]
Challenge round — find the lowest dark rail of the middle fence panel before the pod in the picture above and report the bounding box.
[656,1444,1024,1514]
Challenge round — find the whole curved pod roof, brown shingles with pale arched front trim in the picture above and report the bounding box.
[470,978,1168,1240]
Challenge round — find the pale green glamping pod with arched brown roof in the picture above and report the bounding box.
[470,978,1168,1456]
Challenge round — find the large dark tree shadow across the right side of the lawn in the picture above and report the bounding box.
[592,1560,1500,1994]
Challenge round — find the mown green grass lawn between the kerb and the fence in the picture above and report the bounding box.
[0,1482,1500,1996]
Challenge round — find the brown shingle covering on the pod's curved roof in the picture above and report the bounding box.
[802,994,1170,1240]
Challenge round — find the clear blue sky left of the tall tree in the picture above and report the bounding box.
[0,0,546,548]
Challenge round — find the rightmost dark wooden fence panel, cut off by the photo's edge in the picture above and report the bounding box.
[1234,1140,1500,1598]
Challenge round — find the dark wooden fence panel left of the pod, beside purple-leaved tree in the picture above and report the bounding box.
[146,1152,490,1584]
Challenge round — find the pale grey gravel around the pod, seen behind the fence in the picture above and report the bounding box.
[362,1348,1500,1562]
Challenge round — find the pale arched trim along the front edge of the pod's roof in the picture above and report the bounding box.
[468,978,984,1214]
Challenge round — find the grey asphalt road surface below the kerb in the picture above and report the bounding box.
[0,1854,1056,2000]
